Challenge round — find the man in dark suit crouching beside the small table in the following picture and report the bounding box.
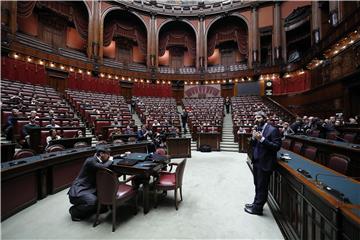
[68,146,113,221]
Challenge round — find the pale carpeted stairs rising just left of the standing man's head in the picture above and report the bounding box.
[220,111,239,152]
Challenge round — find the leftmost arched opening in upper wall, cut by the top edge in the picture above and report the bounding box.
[17,1,89,53]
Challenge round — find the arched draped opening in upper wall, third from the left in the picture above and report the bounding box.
[158,21,196,73]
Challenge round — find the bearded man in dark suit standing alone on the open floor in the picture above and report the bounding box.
[245,111,281,215]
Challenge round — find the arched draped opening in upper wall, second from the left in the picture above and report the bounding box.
[103,9,147,68]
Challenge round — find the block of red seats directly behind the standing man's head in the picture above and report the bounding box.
[231,96,291,142]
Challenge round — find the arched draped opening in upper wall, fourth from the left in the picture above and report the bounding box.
[207,16,249,71]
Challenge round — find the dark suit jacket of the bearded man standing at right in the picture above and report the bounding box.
[251,124,281,171]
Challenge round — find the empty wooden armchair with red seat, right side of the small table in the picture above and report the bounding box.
[154,158,186,210]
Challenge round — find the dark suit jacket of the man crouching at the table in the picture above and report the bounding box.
[68,156,112,197]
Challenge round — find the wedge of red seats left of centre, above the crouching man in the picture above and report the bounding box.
[65,90,137,140]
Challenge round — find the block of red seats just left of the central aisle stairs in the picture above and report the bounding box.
[136,97,180,132]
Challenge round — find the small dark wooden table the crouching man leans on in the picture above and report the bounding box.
[111,159,170,214]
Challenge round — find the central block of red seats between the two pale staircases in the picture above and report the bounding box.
[183,97,224,140]
